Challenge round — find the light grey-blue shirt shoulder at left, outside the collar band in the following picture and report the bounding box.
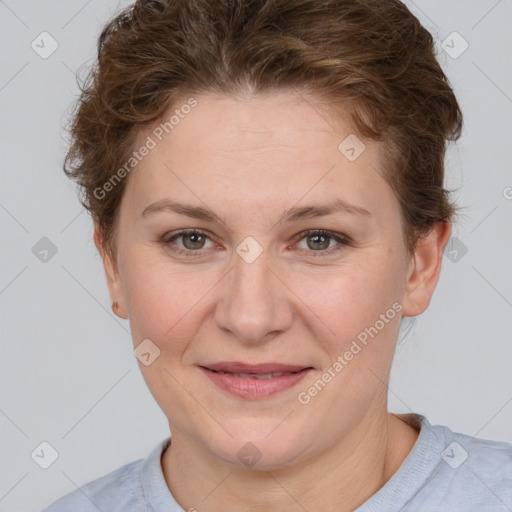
[42,441,169,512]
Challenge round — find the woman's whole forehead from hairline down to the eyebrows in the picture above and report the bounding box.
[120,91,393,225]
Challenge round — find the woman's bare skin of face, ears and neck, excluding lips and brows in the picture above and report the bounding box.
[95,91,450,512]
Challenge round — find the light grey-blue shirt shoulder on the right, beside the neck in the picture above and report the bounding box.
[384,413,512,512]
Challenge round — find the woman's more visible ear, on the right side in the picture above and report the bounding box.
[403,222,452,316]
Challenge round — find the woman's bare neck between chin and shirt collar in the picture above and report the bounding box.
[162,411,418,512]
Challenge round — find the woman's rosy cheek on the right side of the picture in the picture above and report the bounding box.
[292,253,402,378]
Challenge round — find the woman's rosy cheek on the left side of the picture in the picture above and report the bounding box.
[119,255,214,417]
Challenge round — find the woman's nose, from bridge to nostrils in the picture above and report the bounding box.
[215,247,293,345]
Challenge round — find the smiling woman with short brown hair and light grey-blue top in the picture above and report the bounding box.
[45,0,512,512]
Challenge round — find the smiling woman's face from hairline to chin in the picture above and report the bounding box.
[99,92,440,468]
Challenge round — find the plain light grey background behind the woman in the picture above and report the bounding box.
[0,0,512,512]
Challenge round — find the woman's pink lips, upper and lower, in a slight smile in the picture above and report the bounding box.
[199,362,313,400]
